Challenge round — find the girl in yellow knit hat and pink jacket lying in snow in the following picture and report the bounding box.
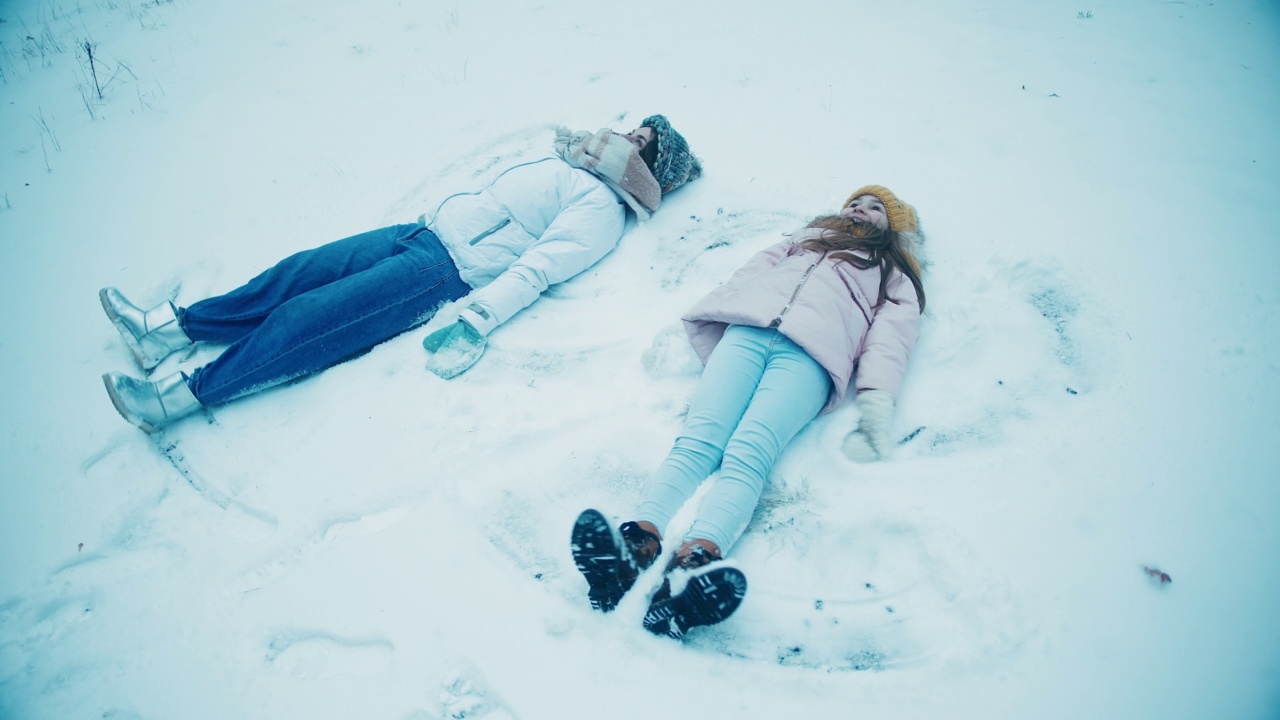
[572,184,924,638]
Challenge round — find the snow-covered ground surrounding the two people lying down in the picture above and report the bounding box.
[0,0,1280,720]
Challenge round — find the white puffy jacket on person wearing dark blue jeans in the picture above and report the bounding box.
[419,158,626,334]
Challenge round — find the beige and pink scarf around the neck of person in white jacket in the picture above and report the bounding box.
[554,126,662,220]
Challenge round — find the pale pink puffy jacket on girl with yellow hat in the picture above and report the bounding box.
[684,228,920,413]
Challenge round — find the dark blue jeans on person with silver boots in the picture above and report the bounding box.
[178,225,471,405]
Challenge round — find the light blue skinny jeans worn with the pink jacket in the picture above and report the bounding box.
[635,325,831,555]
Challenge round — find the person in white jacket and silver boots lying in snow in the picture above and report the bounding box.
[99,115,701,433]
